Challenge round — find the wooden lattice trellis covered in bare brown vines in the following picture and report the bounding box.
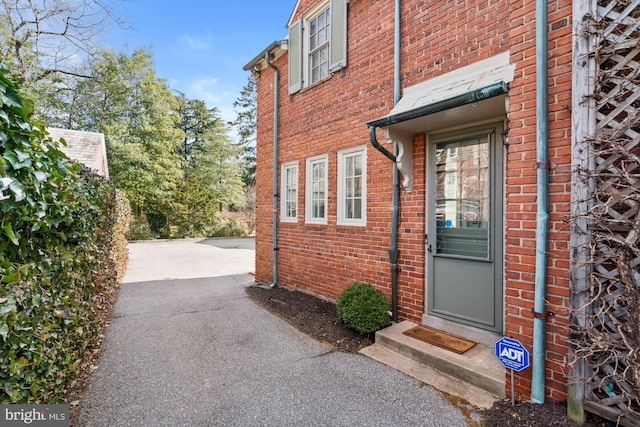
[570,0,640,426]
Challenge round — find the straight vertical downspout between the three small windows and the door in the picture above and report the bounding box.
[389,0,401,323]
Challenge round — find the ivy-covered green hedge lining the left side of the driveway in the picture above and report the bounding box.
[0,70,126,403]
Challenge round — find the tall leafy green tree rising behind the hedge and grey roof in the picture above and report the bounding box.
[69,49,184,221]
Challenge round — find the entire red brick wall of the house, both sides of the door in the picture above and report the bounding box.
[256,0,571,400]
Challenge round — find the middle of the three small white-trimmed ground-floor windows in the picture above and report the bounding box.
[305,155,327,224]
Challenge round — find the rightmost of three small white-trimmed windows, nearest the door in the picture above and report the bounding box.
[338,147,367,225]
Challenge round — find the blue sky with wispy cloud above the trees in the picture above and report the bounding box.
[106,0,295,129]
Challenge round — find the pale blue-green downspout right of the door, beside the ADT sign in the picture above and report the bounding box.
[531,0,550,403]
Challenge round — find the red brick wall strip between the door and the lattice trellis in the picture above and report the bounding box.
[505,0,572,401]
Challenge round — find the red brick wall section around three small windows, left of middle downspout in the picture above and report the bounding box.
[256,1,400,304]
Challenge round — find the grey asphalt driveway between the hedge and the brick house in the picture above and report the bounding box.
[79,239,477,427]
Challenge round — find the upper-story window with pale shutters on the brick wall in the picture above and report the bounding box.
[289,0,347,94]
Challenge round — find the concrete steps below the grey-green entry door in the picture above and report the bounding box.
[361,321,506,408]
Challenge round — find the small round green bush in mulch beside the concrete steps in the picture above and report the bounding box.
[336,282,389,334]
